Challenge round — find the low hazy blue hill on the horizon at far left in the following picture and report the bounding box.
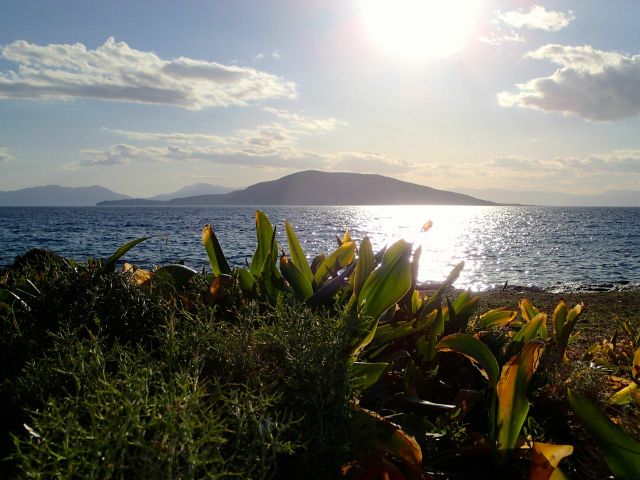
[0,185,131,207]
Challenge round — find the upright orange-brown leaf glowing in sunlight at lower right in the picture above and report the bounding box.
[495,340,544,450]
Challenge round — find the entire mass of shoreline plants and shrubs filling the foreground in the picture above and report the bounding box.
[0,211,640,479]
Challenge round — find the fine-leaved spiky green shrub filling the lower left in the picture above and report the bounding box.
[0,251,364,478]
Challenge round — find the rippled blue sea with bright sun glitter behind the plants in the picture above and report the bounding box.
[0,206,640,290]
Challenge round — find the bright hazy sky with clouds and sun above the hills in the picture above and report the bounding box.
[0,0,640,196]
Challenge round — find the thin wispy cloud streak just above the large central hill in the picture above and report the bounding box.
[66,116,410,173]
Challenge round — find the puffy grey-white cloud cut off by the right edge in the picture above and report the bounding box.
[498,45,640,121]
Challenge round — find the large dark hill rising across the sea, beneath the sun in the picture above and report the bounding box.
[101,170,494,205]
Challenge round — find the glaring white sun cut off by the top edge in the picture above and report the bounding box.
[359,0,482,60]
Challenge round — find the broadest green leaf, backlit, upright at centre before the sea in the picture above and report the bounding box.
[358,240,411,318]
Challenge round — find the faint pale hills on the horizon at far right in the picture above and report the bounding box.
[458,188,640,207]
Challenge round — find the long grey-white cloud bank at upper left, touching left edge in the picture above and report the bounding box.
[0,37,296,110]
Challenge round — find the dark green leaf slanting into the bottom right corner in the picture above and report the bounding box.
[568,390,640,480]
